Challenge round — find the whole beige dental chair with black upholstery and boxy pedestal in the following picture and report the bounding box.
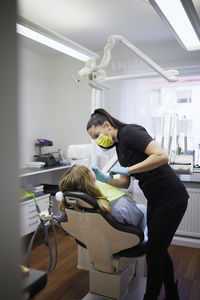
[61,191,146,300]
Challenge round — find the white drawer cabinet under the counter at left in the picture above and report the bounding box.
[19,194,50,237]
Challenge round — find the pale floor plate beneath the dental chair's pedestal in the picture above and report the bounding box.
[82,277,146,300]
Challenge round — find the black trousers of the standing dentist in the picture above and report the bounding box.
[146,200,188,300]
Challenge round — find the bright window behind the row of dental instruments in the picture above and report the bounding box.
[150,76,200,161]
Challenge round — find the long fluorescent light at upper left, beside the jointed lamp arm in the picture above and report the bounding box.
[16,18,99,61]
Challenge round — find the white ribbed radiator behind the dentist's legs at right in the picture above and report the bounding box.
[176,188,200,238]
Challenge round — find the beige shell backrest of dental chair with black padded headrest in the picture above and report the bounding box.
[61,191,144,272]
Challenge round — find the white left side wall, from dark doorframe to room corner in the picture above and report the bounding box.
[18,48,52,167]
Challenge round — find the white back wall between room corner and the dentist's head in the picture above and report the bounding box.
[50,56,91,156]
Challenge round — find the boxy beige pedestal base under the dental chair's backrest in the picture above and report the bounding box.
[77,246,146,300]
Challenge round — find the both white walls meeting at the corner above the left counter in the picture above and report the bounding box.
[18,45,91,167]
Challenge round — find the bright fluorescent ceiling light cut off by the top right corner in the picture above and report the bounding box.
[149,0,200,51]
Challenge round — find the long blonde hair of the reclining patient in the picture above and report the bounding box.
[59,165,111,213]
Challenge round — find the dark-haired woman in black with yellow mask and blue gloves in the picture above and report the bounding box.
[87,109,189,300]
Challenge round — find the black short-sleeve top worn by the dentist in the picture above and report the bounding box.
[116,124,189,210]
